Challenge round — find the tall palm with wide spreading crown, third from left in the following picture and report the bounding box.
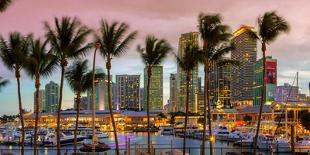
[45,17,91,155]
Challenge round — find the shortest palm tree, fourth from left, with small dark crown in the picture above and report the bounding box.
[65,60,92,154]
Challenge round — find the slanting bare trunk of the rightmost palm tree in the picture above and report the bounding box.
[253,41,266,154]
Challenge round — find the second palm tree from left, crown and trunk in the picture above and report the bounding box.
[25,36,57,154]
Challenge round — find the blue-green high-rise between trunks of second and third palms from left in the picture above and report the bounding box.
[43,81,59,113]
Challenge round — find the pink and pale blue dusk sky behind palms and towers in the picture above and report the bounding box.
[0,0,310,115]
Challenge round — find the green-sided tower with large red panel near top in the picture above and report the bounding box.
[253,56,277,105]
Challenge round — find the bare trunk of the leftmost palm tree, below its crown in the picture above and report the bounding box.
[15,70,25,155]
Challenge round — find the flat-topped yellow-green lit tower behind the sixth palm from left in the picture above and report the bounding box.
[143,66,163,110]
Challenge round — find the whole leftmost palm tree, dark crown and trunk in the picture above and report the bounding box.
[0,32,28,155]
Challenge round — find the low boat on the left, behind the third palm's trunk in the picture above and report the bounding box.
[43,133,85,146]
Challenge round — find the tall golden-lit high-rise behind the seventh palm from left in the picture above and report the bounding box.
[176,32,199,112]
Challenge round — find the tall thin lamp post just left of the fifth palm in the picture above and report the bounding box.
[91,47,98,154]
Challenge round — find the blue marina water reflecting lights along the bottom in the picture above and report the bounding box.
[0,133,278,155]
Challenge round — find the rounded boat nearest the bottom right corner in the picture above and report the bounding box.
[270,137,291,153]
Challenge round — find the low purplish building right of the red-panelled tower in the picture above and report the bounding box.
[275,83,298,102]
